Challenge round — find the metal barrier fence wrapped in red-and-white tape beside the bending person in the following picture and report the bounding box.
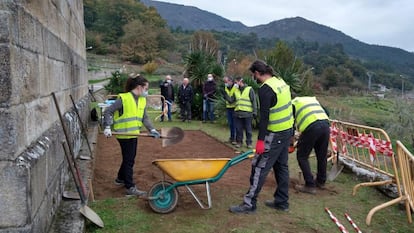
[331,120,402,225]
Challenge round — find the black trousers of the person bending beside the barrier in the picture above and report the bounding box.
[296,120,330,187]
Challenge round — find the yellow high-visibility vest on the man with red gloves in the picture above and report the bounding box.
[262,77,294,132]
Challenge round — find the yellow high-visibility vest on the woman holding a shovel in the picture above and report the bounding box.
[114,92,147,138]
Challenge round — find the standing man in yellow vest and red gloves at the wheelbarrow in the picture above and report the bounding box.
[229,60,294,214]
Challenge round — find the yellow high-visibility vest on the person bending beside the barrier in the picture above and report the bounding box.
[292,97,329,132]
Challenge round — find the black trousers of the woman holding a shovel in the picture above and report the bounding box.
[117,138,138,189]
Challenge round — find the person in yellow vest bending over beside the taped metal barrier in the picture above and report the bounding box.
[292,97,330,194]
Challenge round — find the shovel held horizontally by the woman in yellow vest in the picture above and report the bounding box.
[112,127,184,147]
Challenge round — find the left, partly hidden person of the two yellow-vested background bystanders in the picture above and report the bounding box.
[223,76,236,145]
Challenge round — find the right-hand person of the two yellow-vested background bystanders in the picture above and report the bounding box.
[234,77,257,149]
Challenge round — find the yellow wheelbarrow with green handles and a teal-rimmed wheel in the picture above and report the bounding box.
[146,150,254,214]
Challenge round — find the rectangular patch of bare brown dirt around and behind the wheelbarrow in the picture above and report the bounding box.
[93,131,336,200]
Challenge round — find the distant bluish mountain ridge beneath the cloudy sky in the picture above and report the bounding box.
[141,0,414,75]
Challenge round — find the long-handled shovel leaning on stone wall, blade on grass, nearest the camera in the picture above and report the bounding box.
[62,142,104,227]
